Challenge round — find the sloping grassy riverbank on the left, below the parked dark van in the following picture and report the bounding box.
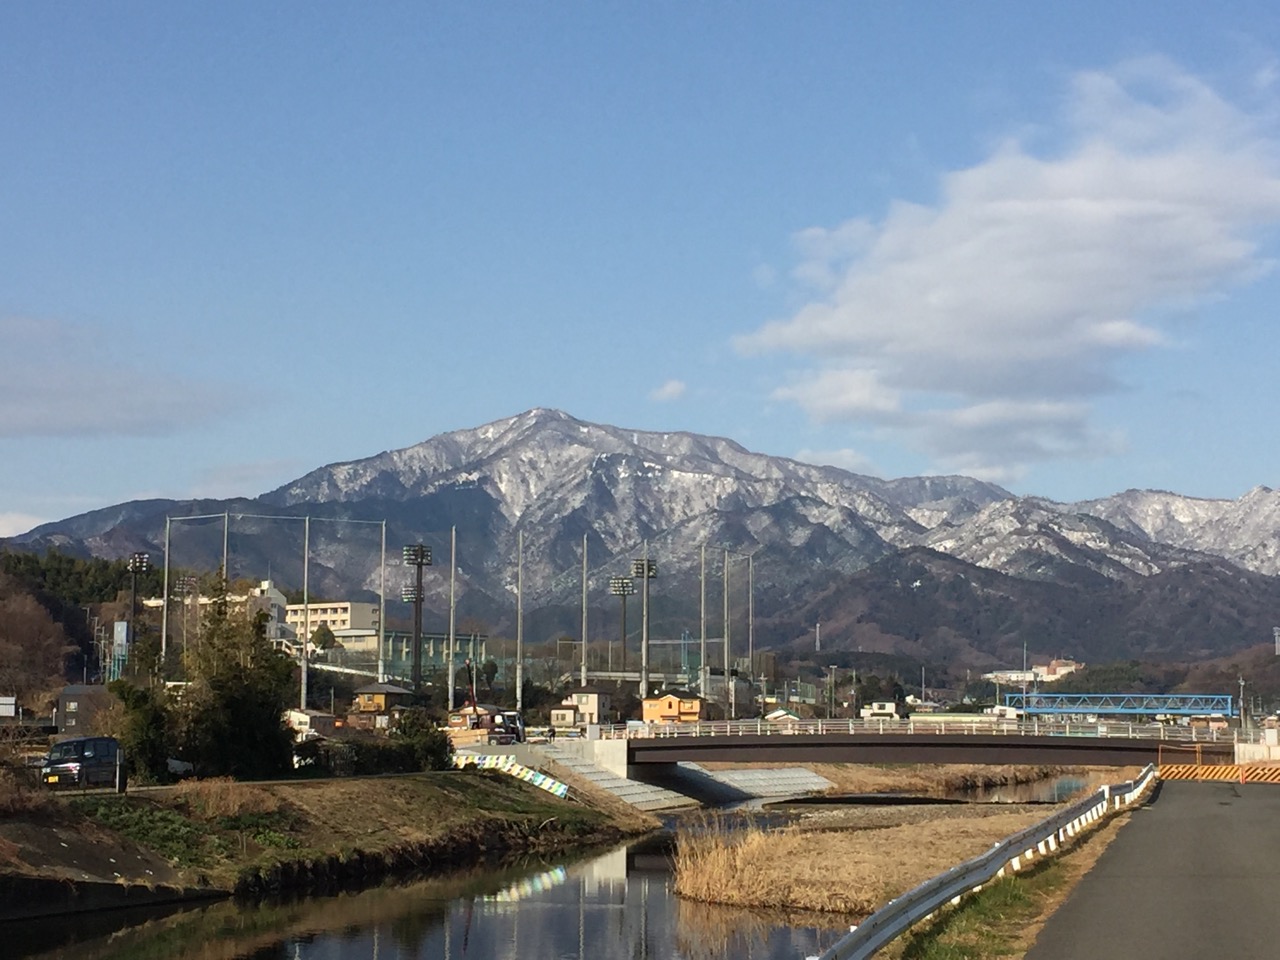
[0,771,658,916]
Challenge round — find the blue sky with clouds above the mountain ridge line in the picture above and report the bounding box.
[0,1,1280,534]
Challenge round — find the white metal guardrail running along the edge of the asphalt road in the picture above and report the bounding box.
[818,765,1156,960]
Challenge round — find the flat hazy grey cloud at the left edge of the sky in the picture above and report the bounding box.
[0,317,244,438]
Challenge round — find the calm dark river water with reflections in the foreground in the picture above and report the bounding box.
[15,842,846,960]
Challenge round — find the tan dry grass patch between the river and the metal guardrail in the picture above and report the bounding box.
[676,810,1044,916]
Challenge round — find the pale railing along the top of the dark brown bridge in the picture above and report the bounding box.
[600,713,1261,744]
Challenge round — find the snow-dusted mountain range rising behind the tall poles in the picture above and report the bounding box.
[8,408,1280,660]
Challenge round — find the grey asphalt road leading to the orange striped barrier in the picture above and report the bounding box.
[1025,781,1280,960]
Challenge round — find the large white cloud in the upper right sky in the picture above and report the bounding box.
[736,59,1280,480]
